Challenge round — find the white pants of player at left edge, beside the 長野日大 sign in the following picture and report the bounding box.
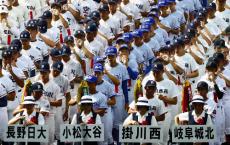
[0,107,8,140]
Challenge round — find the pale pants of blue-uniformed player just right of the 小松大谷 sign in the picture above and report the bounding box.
[99,107,113,145]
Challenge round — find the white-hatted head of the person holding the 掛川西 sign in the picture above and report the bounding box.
[135,97,150,115]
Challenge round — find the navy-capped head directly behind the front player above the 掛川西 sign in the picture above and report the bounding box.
[152,62,164,80]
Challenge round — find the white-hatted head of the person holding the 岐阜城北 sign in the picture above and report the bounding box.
[191,95,205,114]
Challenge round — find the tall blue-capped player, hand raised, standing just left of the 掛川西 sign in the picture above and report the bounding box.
[105,47,129,143]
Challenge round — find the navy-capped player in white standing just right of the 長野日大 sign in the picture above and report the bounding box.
[39,62,64,144]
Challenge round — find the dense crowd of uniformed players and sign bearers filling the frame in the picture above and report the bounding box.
[0,0,230,145]
